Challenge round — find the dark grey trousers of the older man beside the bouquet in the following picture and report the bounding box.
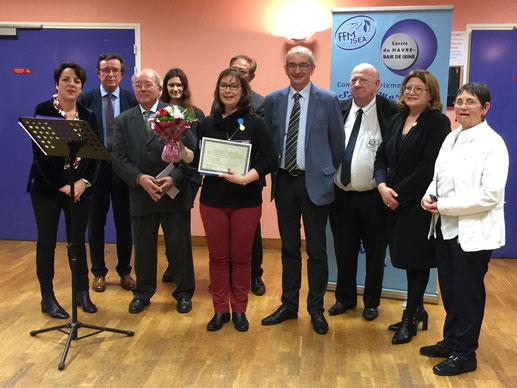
[133,210,195,300]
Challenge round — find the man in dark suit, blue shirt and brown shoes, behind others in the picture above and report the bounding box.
[78,53,138,292]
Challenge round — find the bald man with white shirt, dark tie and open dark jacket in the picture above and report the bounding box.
[329,63,398,321]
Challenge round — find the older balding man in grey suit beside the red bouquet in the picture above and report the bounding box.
[113,69,194,314]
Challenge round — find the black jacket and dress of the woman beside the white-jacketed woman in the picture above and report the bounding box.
[374,107,451,269]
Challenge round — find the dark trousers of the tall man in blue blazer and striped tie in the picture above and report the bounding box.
[275,170,330,313]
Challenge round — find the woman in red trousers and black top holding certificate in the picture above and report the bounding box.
[197,68,276,331]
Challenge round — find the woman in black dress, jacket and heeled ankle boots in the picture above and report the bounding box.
[374,70,451,344]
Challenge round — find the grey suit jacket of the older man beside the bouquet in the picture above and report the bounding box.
[112,101,192,216]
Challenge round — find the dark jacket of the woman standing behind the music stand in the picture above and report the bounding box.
[27,99,98,199]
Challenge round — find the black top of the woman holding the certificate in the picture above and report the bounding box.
[194,111,277,209]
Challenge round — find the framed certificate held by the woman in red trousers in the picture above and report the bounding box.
[198,137,251,175]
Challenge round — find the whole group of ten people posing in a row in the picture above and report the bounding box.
[28,46,508,375]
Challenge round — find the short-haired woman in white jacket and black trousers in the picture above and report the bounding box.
[420,83,508,376]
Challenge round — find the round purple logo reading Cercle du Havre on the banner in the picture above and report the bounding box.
[381,19,438,76]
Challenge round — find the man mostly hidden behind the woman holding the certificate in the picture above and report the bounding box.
[210,54,266,296]
